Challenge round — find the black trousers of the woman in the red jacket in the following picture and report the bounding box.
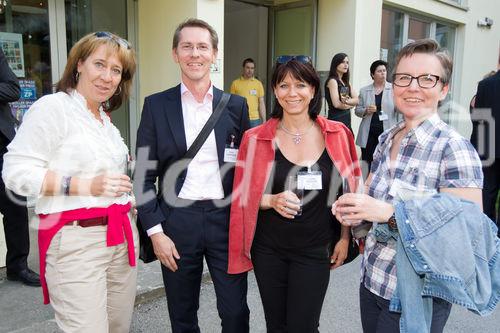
[251,243,331,333]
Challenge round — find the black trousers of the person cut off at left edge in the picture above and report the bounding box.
[0,156,30,273]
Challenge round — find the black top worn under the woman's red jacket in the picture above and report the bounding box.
[254,149,338,249]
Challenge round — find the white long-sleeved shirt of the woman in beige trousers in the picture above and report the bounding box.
[2,90,129,214]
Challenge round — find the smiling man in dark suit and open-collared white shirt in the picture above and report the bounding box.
[134,19,249,333]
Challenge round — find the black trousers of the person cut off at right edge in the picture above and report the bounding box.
[483,158,500,237]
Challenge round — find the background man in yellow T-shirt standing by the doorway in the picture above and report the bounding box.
[231,58,266,127]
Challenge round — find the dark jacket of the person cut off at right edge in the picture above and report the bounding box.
[473,70,500,158]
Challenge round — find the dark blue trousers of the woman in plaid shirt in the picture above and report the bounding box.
[359,284,451,333]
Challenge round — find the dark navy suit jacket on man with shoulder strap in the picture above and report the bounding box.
[134,85,249,230]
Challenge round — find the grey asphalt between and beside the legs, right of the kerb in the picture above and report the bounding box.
[131,261,500,333]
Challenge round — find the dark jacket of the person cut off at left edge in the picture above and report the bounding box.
[0,48,21,146]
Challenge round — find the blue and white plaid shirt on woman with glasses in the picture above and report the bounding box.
[361,114,483,300]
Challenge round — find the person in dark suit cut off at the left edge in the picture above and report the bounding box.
[0,48,40,287]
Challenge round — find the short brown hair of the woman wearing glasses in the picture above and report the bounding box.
[394,38,453,84]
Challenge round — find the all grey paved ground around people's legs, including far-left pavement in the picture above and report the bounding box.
[0,254,500,333]
